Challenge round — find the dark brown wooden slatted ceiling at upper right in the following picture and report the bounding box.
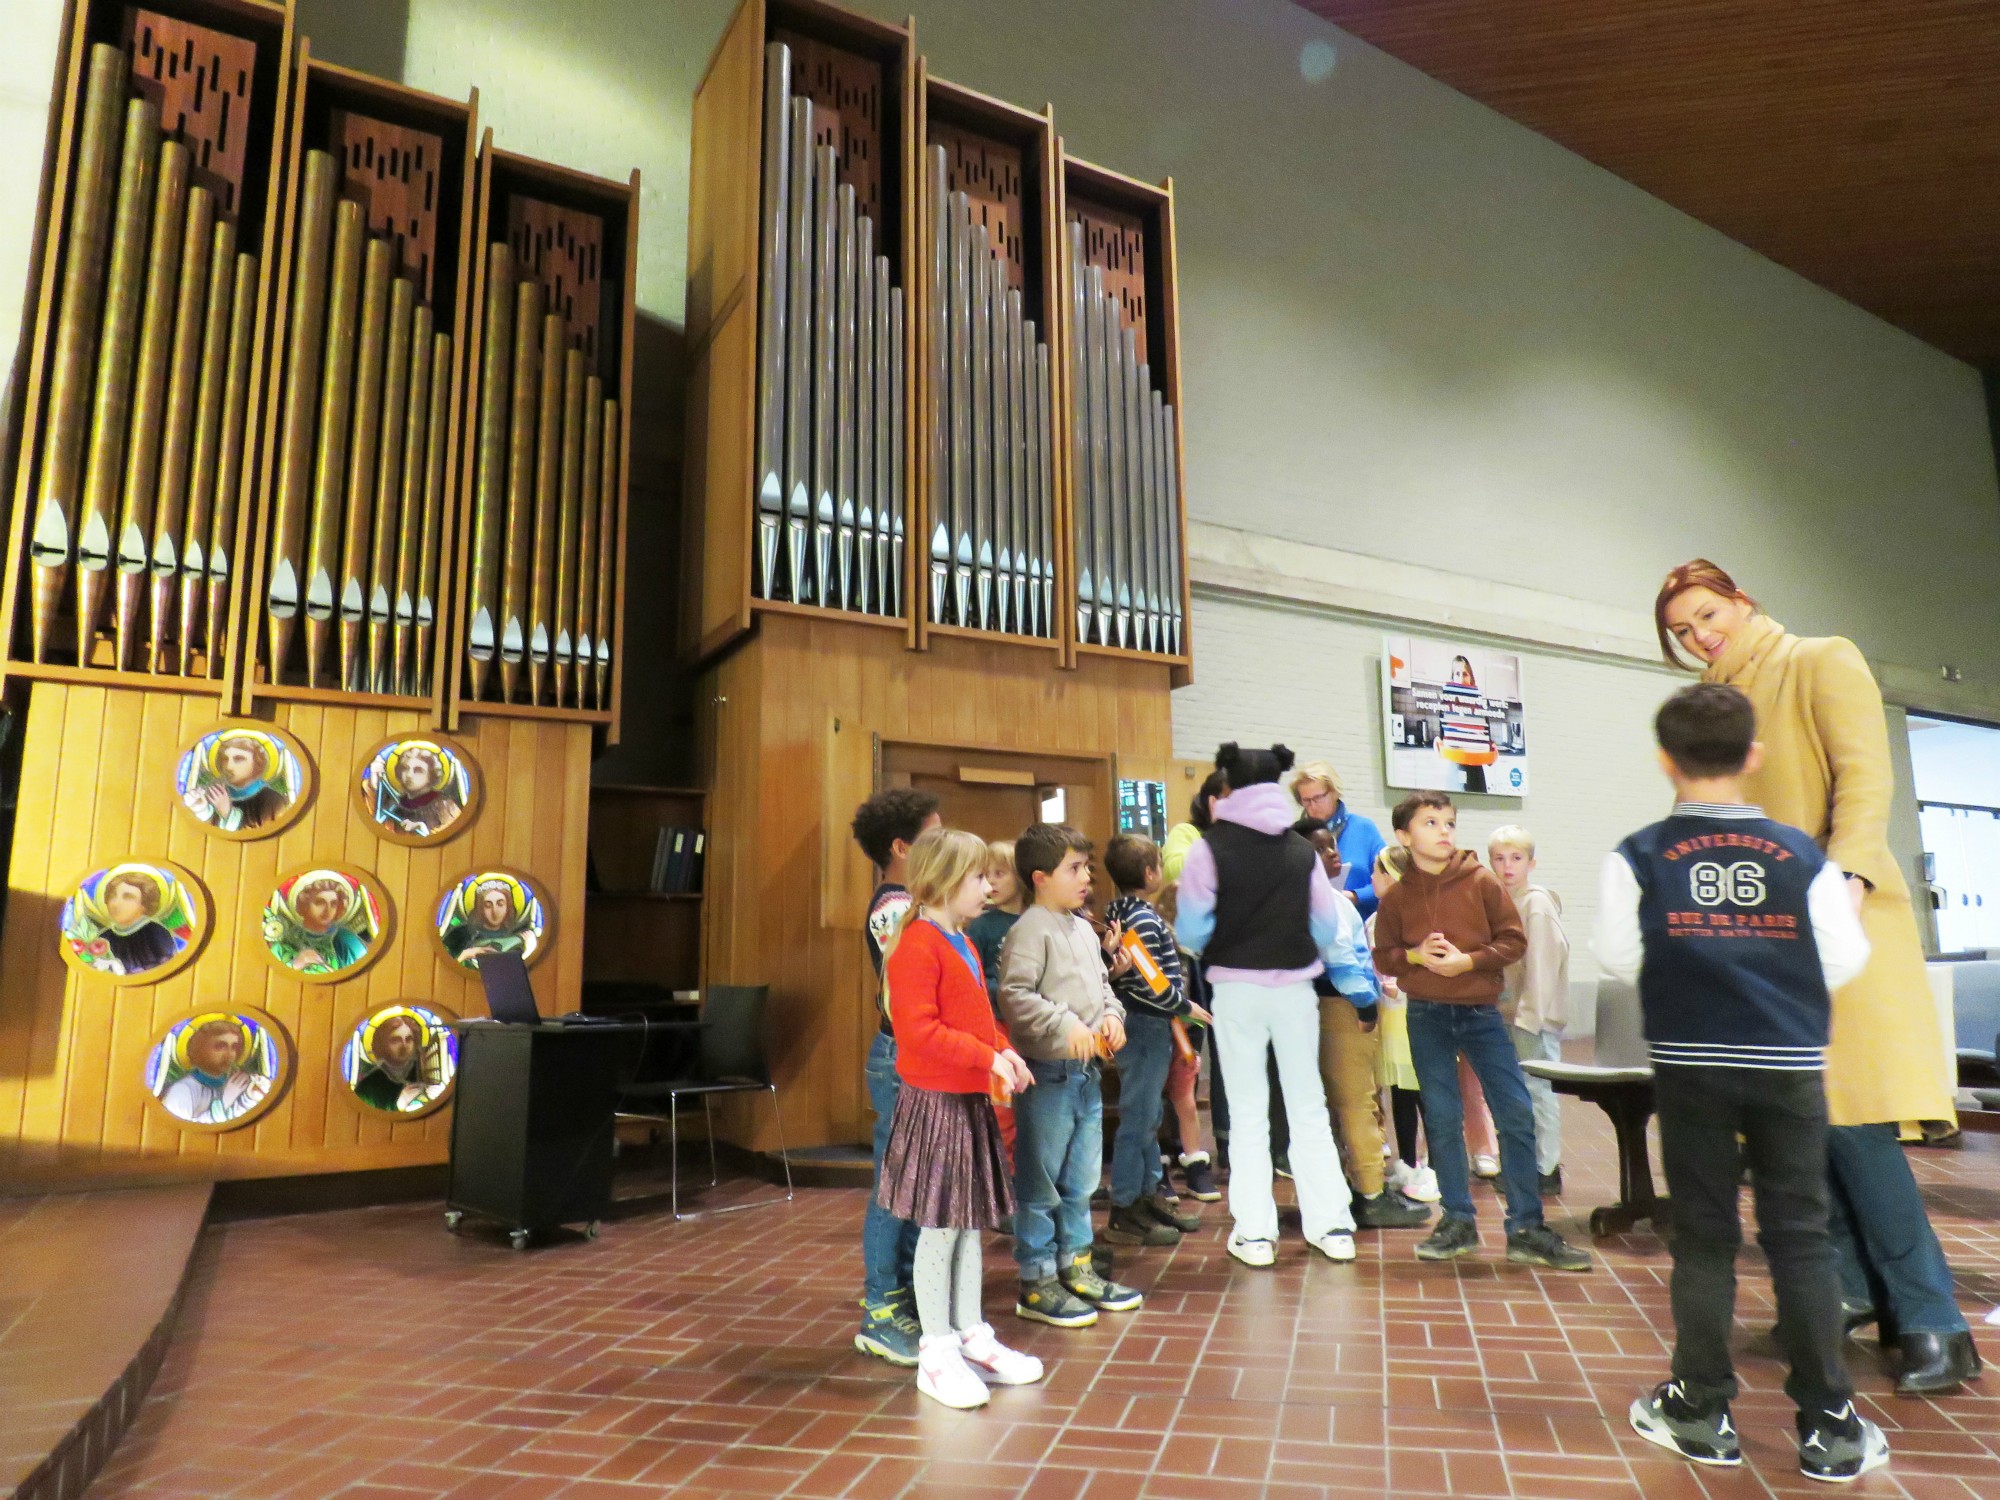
[1298,0,2000,366]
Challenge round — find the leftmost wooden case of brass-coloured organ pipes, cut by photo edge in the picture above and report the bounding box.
[0,0,292,694]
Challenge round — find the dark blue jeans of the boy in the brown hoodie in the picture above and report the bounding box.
[1408,1000,1542,1234]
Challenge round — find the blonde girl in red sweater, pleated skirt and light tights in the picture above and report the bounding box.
[876,828,1042,1408]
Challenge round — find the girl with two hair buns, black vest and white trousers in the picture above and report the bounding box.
[1174,742,1374,1266]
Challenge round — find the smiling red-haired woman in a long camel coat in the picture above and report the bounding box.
[1654,558,1980,1396]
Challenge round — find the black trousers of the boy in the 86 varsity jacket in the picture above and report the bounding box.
[1652,1064,1854,1412]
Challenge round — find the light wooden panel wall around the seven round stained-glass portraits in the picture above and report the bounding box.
[0,682,590,1186]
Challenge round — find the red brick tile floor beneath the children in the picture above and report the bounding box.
[90,1102,2000,1500]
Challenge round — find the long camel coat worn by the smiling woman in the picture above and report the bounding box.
[1702,614,1956,1124]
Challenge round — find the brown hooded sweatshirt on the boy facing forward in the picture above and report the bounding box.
[1374,848,1528,1006]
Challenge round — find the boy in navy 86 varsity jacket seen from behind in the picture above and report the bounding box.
[1596,682,1888,1482]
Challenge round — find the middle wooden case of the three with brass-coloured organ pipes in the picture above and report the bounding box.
[240,58,478,716]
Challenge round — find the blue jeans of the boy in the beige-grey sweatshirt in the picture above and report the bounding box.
[1014,1058,1104,1282]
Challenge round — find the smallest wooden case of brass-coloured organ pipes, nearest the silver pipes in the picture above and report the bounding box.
[446,142,638,744]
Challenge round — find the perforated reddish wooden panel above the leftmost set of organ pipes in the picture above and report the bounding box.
[124,6,256,218]
